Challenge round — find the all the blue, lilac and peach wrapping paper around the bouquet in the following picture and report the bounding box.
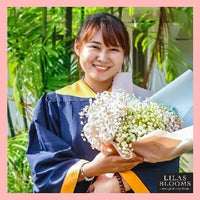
[113,70,193,163]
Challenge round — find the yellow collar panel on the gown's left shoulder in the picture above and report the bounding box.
[56,80,96,98]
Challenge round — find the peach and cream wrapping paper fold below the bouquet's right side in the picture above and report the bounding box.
[132,126,193,163]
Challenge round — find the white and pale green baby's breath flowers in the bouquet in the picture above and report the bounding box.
[80,89,183,158]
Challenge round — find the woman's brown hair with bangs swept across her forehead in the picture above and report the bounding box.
[77,13,130,57]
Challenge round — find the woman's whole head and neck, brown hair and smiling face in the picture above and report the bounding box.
[74,13,130,92]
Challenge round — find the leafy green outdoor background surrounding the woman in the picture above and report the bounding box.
[7,7,193,193]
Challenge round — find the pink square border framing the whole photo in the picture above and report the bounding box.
[0,0,200,200]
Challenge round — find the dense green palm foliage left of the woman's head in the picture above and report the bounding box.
[8,8,78,109]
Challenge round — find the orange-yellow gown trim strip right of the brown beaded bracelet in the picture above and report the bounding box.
[120,170,150,193]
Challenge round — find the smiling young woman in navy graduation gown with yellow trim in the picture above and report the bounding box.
[27,13,179,193]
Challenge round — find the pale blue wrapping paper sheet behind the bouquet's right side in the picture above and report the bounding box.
[149,70,193,127]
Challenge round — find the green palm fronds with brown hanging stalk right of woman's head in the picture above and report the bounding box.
[131,7,193,87]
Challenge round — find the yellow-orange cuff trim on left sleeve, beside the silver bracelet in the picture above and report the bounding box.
[60,160,88,193]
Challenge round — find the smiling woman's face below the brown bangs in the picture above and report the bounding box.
[75,30,124,84]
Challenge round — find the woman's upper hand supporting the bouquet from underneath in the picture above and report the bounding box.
[80,153,143,177]
